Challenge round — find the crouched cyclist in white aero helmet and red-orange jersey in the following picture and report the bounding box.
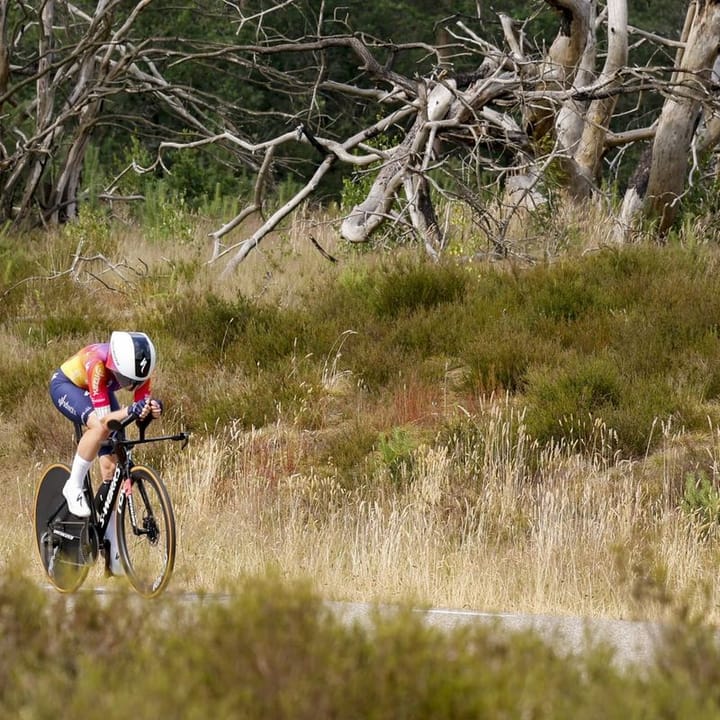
[50,331,162,517]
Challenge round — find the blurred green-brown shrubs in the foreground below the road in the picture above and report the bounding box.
[0,570,720,720]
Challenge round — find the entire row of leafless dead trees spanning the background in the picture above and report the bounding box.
[0,0,720,273]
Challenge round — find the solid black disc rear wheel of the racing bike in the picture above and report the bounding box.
[35,463,92,593]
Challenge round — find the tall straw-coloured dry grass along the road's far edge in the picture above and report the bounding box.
[152,401,720,617]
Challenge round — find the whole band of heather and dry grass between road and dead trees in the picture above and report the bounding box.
[5,217,720,613]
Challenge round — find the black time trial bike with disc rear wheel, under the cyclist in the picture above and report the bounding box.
[35,414,190,598]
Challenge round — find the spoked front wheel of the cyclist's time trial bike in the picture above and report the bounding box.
[116,465,175,598]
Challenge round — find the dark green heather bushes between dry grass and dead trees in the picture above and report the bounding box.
[156,248,720,455]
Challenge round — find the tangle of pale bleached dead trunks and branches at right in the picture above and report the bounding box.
[198,0,720,272]
